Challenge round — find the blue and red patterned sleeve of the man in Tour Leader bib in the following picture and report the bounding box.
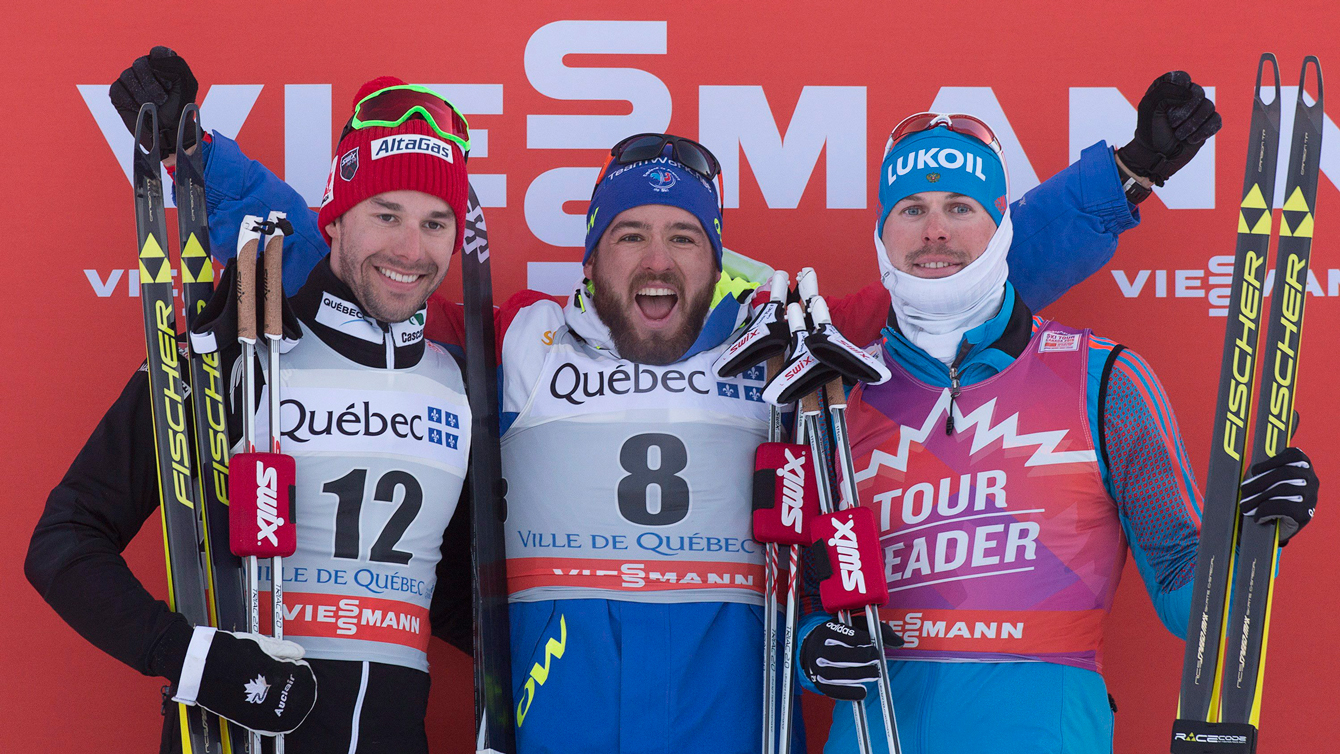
[1089,337,1202,639]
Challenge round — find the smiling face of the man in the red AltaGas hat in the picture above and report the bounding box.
[326,190,457,323]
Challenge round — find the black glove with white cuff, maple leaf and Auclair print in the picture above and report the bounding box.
[173,625,316,735]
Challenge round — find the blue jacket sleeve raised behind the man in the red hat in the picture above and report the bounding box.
[195,131,330,296]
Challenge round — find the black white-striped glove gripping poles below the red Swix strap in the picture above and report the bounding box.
[800,620,903,702]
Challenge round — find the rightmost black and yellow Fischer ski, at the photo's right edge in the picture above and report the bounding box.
[1221,55,1323,727]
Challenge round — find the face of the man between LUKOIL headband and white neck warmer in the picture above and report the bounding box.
[880,192,996,279]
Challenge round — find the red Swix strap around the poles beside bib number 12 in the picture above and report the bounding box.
[228,453,297,557]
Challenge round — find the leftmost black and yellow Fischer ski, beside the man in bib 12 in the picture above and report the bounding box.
[134,103,222,754]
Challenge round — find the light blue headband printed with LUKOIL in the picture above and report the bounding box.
[875,127,1009,236]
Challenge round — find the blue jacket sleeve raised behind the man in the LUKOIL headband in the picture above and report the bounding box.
[1009,142,1140,312]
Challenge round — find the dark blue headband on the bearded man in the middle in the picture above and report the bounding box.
[582,145,721,269]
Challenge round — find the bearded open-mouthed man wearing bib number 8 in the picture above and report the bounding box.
[107,48,1307,754]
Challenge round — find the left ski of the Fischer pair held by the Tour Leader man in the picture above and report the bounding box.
[1173,52,1280,751]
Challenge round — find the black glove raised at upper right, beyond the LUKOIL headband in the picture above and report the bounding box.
[1116,71,1223,186]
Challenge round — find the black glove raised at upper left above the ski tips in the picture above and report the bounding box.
[107,46,200,157]
